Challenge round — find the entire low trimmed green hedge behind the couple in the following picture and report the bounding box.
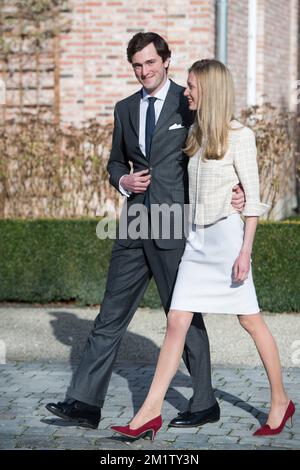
[0,219,300,312]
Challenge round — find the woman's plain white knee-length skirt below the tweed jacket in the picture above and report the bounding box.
[170,213,260,315]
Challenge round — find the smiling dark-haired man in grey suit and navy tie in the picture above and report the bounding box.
[47,33,244,428]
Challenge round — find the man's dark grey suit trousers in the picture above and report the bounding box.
[67,239,216,412]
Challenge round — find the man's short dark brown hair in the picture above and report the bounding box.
[127,32,171,63]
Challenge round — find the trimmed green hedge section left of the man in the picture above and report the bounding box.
[0,220,111,303]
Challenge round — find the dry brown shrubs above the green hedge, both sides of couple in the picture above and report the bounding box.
[0,104,297,219]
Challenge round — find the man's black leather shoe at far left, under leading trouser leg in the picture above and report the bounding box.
[46,400,101,429]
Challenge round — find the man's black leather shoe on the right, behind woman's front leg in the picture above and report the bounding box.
[169,402,220,428]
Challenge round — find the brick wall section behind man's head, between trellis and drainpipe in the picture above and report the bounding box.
[60,0,215,124]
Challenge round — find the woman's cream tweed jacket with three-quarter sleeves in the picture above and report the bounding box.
[188,120,269,225]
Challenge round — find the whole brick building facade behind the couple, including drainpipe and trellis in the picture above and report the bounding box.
[0,0,299,125]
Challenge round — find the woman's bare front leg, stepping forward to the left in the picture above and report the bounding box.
[130,310,194,429]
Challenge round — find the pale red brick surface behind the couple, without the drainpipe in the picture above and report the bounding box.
[0,0,299,125]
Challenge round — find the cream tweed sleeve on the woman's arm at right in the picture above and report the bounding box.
[233,127,269,216]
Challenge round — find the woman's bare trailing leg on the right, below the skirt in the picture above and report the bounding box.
[238,313,289,428]
